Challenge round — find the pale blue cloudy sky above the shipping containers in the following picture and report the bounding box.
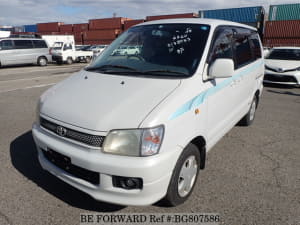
[0,0,299,26]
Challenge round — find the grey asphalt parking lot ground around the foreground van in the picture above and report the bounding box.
[0,65,300,225]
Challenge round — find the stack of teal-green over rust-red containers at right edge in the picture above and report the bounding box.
[264,4,300,47]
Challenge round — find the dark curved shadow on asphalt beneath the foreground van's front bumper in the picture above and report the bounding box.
[10,131,125,212]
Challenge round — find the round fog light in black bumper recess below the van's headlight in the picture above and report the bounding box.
[113,176,143,190]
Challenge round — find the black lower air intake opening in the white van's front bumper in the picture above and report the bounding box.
[42,149,100,185]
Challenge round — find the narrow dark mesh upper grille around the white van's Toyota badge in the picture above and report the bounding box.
[40,117,104,147]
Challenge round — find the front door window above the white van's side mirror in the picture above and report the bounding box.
[208,28,233,64]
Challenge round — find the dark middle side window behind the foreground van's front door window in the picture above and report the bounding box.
[233,31,254,68]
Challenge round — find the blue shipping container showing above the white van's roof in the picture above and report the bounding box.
[199,6,264,23]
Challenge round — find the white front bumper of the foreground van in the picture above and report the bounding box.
[32,124,182,205]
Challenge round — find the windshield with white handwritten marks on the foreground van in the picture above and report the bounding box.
[86,24,210,77]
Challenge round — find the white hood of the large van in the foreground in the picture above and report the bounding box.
[40,70,180,131]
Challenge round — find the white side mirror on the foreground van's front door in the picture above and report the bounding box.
[208,59,234,78]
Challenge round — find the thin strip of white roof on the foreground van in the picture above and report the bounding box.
[135,18,256,30]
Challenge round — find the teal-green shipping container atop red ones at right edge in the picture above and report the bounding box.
[269,4,300,21]
